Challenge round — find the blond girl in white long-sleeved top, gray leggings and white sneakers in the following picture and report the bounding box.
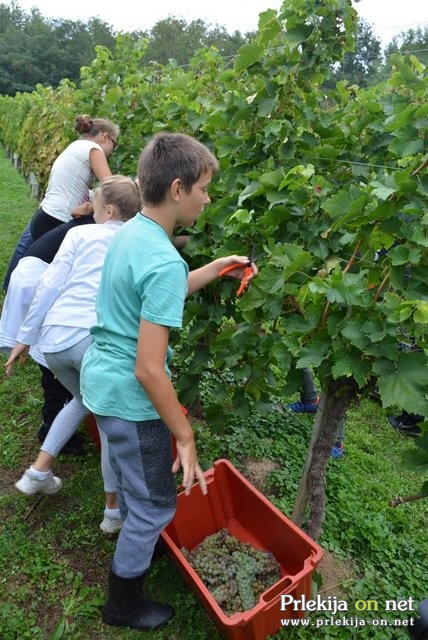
[6,176,140,532]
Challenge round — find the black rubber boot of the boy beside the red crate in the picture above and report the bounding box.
[101,569,174,630]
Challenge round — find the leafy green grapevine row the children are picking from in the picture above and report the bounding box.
[0,0,428,426]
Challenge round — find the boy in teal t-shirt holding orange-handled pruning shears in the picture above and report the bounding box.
[81,133,256,629]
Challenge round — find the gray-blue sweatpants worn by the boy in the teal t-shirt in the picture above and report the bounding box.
[96,415,177,578]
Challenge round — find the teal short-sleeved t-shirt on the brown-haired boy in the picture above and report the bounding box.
[80,213,189,421]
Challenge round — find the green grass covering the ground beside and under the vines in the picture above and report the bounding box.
[0,146,428,640]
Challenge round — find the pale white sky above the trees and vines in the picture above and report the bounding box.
[7,0,428,46]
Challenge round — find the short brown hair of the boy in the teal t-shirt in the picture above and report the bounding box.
[138,132,218,205]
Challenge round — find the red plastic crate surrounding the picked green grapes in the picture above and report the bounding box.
[162,460,322,640]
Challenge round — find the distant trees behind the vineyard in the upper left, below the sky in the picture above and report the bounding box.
[0,1,251,96]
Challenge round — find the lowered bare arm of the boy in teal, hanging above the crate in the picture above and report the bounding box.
[135,320,207,495]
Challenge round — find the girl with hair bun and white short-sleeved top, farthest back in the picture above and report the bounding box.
[3,115,119,290]
